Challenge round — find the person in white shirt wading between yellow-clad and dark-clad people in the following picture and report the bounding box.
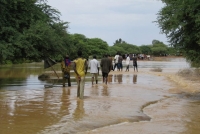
[89,55,100,85]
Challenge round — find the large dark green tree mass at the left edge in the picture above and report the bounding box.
[0,0,68,63]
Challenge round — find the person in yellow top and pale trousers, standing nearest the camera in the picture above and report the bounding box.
[73,51,88,99]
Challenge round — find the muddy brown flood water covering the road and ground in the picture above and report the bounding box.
[0,58,200,134]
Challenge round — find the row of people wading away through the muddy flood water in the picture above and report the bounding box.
[61,51,138,99]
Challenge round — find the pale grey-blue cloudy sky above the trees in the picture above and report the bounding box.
[48,0,168,46]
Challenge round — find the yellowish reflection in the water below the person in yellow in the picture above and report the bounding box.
[73,99,85,120]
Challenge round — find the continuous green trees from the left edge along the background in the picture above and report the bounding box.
[0,0,198,67]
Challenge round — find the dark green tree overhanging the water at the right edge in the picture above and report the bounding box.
[156,0,200,67]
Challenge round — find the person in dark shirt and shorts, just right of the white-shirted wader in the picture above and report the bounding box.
[100,54,112,85]
